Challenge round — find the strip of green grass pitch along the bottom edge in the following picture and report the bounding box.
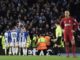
[0,56,80,60]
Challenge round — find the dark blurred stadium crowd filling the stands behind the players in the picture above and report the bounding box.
[0,0,80,55]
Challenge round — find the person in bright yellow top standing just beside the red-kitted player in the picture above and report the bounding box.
[53,21,63,55]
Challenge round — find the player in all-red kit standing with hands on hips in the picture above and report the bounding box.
[60,10,78,57]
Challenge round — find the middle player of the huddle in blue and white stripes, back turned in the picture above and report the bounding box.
[11,28,19,55]
